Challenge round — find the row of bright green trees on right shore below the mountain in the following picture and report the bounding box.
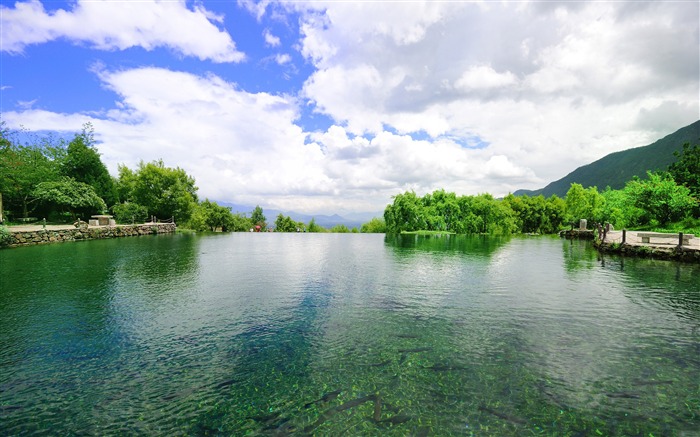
[384,144,700,235]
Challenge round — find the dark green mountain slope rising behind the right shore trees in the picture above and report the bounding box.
[513,120,700,197]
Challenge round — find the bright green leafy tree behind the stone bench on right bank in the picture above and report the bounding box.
[625,172,698,226]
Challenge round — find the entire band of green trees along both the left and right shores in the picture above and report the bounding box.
[0,123,700,235]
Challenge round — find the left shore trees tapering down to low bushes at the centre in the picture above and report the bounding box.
[0,122,384,232]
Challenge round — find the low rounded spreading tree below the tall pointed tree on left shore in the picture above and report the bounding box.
[32,178,107,219]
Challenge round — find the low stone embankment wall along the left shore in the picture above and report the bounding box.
[9,223,176,247]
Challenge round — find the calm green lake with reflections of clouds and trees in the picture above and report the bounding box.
[0,233,700,436]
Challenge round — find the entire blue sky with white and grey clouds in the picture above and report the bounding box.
[0,0,700,214]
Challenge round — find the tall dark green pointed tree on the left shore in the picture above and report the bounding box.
[61,123,119,205]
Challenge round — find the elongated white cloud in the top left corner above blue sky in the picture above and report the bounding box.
[0,0,245,62]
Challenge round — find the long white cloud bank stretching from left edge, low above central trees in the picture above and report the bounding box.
[3,67,531,213]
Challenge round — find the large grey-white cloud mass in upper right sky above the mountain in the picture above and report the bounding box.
[287,2,700,187]
